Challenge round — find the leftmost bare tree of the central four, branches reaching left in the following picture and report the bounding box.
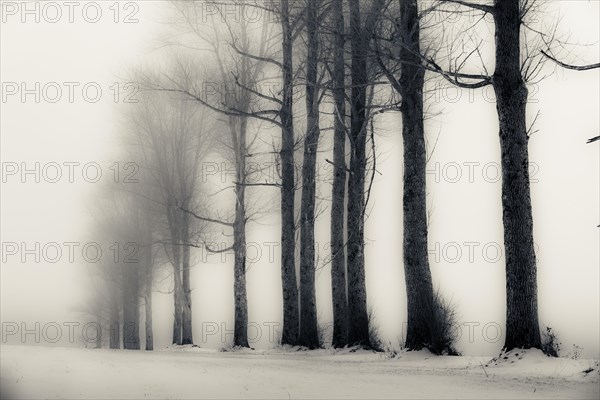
[162,0,308,345]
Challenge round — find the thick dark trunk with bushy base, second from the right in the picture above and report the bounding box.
[398,0,436,350]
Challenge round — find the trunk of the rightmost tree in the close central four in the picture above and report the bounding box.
[347,1,370,347]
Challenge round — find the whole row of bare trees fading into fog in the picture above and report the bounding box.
[85,0,594,354]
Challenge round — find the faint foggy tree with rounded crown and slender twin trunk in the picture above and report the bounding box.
[130,91,208,344]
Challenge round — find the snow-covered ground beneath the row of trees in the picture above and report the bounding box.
[1,345,600,399]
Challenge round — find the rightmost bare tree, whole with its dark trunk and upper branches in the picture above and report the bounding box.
[426,0,553,350]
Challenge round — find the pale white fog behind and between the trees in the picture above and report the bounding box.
[0,1,600,357]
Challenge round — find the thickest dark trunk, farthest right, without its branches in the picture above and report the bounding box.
[493,0,541,350]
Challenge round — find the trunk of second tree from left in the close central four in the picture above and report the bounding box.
[299,0,320,349]
